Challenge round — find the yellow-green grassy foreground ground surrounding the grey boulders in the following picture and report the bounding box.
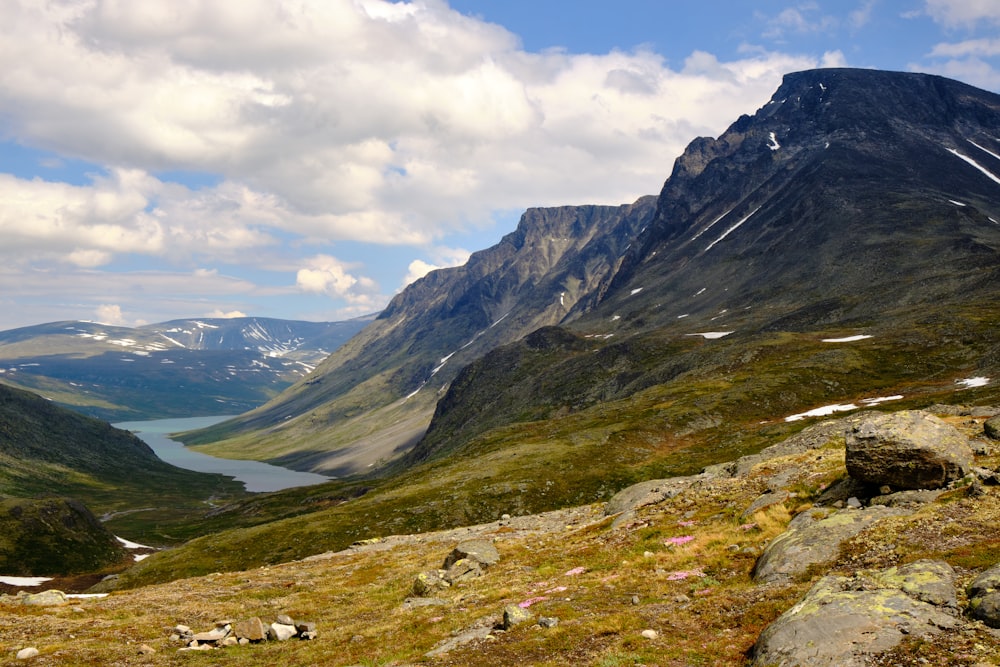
[0,410,1000,667]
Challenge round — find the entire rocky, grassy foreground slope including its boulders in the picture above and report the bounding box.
[0,406,1000,667]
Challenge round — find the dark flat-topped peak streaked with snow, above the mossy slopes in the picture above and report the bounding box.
[601,65,1000,328]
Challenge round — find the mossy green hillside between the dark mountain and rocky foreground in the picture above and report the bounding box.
[107,312,1000,584]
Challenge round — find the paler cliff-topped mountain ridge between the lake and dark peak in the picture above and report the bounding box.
[189,197,654,474]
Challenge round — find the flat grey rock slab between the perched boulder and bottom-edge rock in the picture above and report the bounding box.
[753,507,908,583]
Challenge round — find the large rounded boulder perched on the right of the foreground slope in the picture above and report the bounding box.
[846,410,973,489]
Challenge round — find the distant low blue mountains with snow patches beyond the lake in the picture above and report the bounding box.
[0,317,368,421]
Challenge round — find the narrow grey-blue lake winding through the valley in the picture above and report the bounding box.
[114,416,330,493]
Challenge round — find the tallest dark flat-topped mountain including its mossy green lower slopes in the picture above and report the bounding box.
[406,70,1000,463]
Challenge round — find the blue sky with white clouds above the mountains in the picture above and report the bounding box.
[0,0,1000,330]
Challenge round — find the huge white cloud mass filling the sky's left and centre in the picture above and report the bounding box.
[0,0,817,265]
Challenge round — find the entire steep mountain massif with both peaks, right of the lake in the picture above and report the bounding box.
[188,69,1000,486]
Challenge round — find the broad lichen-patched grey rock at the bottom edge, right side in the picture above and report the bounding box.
[753,561,958,667]
